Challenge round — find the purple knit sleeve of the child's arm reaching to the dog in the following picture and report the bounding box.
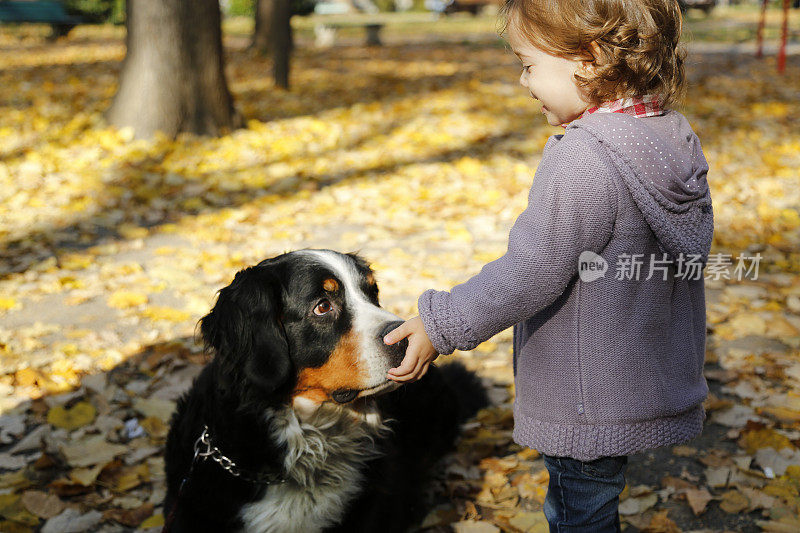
[418,135,617,354]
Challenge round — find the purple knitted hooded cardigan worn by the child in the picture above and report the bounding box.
[418,111,713,461]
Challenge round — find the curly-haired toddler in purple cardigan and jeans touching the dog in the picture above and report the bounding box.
[385,0,713,532]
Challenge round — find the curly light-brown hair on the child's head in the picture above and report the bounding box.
[500,0,686,107]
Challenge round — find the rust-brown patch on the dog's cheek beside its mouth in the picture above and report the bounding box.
[292,331,368,403]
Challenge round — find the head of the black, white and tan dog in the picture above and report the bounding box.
[201,250,407,412]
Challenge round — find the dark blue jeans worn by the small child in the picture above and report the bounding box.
[544,455,628,533]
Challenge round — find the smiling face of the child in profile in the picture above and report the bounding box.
[508,20,592,126]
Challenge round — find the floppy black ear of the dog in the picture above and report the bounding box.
[200,266,291,394]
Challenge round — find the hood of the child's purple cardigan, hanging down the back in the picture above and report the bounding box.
[567,111,714,264]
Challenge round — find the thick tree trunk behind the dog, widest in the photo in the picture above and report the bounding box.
[106,0,244,139]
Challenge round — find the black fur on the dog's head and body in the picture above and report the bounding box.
[164,252,488,533]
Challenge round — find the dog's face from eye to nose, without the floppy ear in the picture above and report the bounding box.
[286,250,405,412]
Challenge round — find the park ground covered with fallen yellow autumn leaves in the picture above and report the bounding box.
[0,12,800,532]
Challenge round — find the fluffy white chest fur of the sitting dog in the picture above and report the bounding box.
[240,405,388,533]
